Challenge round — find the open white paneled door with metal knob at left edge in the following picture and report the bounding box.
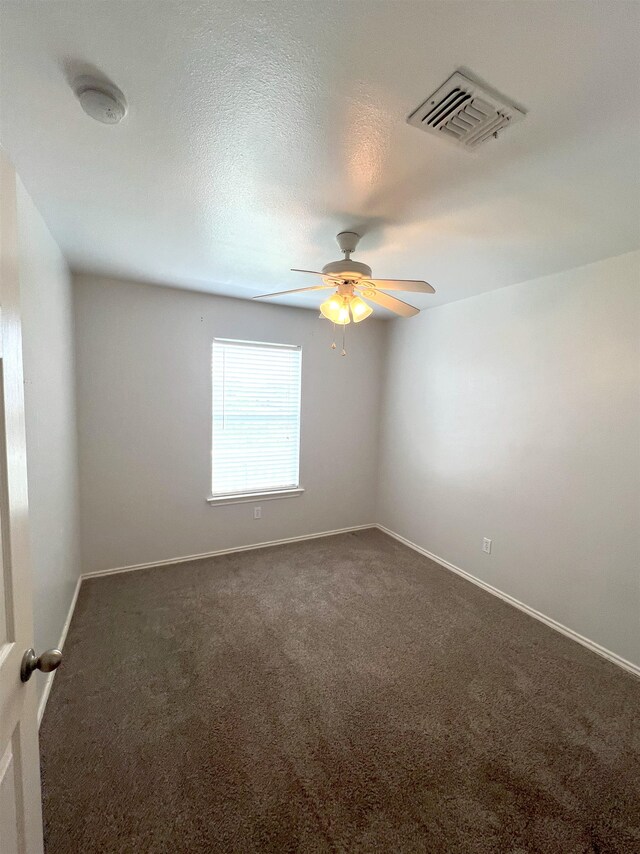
[0,150,43,854]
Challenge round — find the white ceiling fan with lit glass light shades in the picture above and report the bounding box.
[253,231,435,326]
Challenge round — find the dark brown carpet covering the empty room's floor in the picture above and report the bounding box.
[41,530,640,854]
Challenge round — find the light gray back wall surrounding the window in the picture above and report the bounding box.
[75,275,384,571]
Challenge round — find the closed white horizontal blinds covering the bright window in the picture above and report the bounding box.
[211,338,302,498]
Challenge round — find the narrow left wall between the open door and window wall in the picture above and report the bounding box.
[17,181,80,690]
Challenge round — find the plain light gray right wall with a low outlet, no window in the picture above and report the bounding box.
[378,252,640,663]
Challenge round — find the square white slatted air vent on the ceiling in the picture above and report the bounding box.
[407,71,525,151]
